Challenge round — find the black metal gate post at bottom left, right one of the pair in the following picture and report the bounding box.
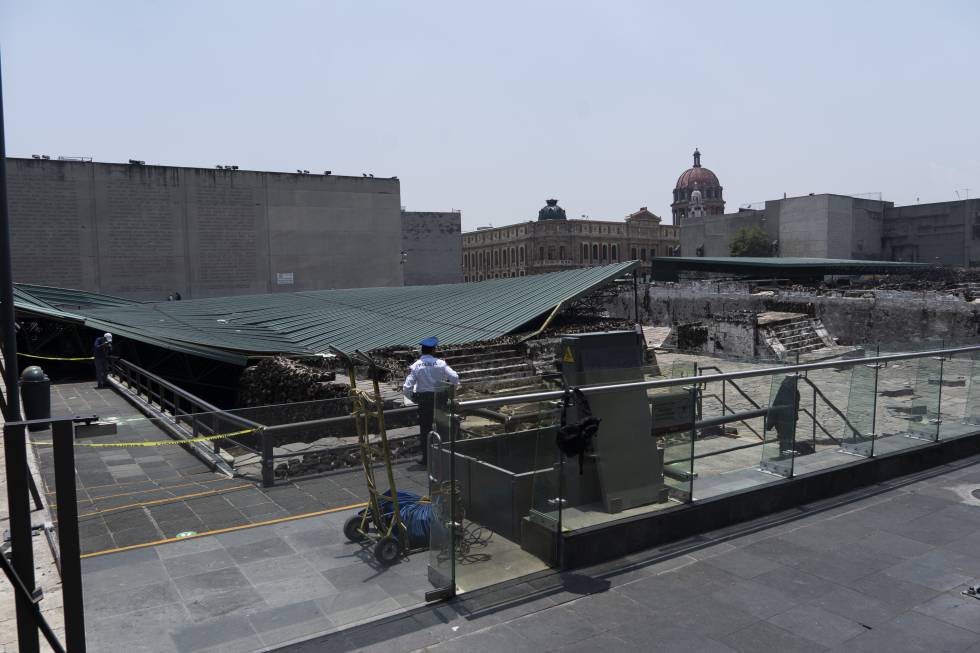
[51,419,85,653]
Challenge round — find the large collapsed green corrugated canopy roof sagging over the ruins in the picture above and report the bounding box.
[14,261,639,364]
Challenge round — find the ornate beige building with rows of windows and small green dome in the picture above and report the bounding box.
[462,200,680,282]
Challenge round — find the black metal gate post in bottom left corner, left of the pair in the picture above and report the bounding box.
[0,422,38,653]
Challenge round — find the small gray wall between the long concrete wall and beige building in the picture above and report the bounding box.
[402,211,463,286]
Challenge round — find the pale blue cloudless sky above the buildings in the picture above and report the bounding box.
[0,0,980,229]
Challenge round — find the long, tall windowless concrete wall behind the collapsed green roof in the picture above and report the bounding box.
[7,159,402,299]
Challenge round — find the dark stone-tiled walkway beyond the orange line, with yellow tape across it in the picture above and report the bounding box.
[32,383,427,554]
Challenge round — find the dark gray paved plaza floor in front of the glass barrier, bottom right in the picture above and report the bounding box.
[274,457,980,653]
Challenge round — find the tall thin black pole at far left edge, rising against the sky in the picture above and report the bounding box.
[0,48,22,422]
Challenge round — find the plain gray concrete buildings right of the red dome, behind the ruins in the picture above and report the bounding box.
[680,193,980,266]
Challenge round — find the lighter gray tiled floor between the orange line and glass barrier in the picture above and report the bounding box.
[82,511,431,652]
